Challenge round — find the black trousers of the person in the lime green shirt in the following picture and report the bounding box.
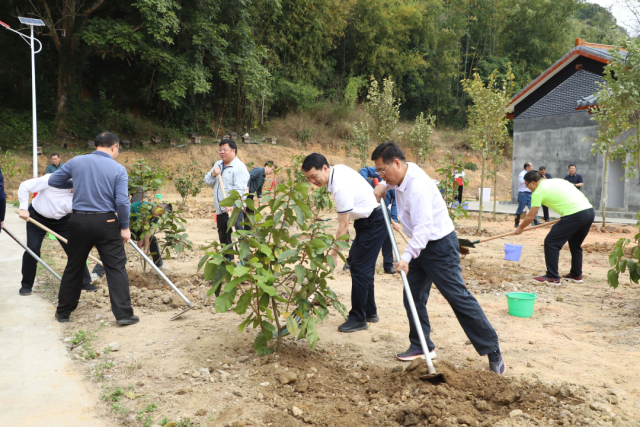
[544,208,596,279]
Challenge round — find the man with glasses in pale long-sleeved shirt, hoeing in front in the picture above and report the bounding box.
[371,142,506,375]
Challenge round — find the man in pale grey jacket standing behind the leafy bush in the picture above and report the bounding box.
[204,139,249,260]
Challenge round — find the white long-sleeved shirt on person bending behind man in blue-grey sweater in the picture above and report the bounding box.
[18,174,73,219]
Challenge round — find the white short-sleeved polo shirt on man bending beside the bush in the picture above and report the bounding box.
[327,165,380,219]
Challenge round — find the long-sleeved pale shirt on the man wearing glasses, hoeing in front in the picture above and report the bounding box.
[387,162,455,262]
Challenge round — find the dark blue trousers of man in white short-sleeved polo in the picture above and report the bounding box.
[349,209,389,322]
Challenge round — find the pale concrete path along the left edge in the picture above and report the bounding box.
[0,206,106,427]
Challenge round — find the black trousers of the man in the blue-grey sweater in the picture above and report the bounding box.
[58,213,133,320]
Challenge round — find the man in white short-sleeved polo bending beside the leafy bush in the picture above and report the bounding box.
[302,153,388,332]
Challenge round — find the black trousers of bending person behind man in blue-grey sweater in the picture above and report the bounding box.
[22,206,91,289]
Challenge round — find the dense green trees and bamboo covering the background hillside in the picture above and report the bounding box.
[0,0,622,148]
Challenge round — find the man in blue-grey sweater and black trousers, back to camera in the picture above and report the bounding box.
[49,132,140,325]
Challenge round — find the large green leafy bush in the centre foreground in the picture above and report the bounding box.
[198,179,349,355]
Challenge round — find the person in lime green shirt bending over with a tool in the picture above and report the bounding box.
[516,171,595,283]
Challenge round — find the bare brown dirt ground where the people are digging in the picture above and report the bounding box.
[28,195,640,427]
